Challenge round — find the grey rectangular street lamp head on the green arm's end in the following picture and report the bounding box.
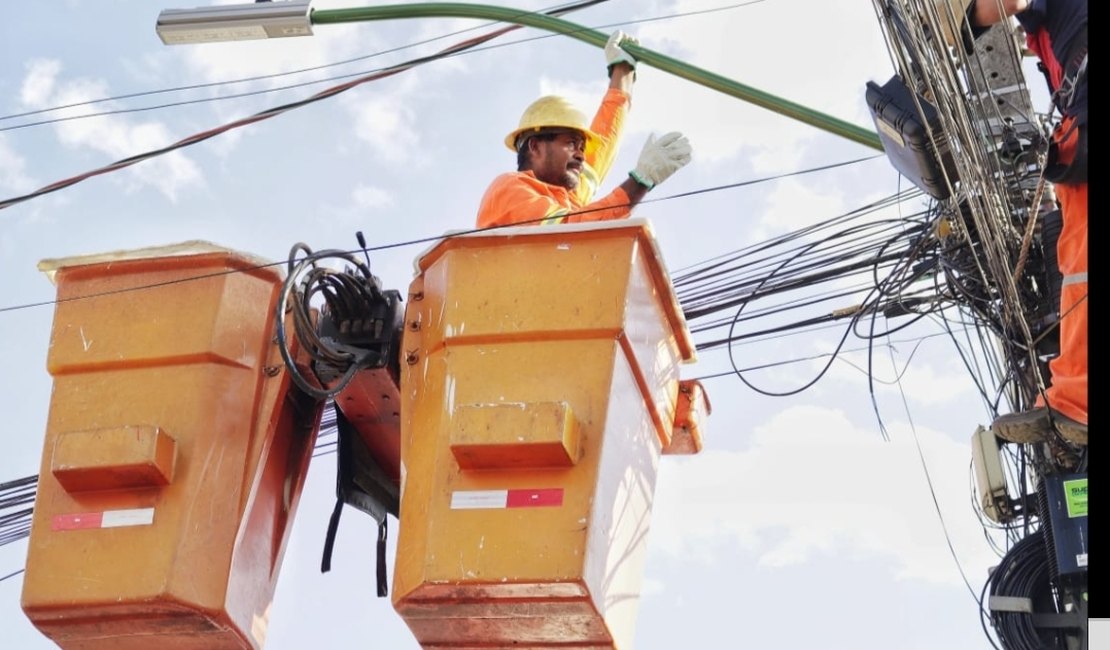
[155,0,312,45]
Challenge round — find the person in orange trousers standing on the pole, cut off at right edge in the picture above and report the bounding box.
[967,0,1087,445]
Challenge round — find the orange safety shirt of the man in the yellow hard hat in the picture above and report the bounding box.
[477,88,632,227]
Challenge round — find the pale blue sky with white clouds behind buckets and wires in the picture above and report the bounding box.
[0,0,1094,650]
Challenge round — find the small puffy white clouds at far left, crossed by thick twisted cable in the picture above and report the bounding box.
[20,60,203,201]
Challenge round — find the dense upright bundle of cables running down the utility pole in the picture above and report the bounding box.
[874,0,1057,419]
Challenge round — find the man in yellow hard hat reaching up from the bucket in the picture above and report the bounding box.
[477,31,690,227]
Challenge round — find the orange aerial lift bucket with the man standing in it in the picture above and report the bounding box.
[392,220,708,649]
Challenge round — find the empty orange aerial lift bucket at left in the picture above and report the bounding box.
[22,242,320,650]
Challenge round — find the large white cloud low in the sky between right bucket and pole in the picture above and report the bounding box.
[652,406,991,583]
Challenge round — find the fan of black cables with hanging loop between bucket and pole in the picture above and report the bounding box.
[673,183,959,396]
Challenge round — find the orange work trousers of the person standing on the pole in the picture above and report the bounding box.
[1047,115,1087,424]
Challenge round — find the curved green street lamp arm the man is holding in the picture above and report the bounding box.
[311,2,882,151]
